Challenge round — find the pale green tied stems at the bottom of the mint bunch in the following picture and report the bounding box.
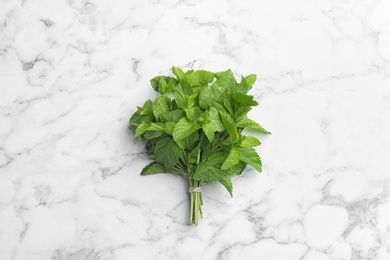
[189,179,203,226]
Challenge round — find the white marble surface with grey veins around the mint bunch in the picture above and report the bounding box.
[0,0,390,260]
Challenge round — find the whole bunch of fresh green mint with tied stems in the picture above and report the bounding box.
[130,67,270,225]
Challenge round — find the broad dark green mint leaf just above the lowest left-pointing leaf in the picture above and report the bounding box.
[154,137,182,171]
